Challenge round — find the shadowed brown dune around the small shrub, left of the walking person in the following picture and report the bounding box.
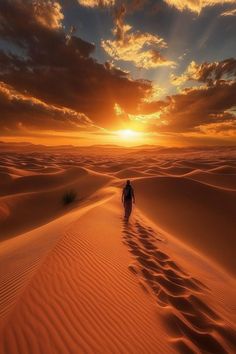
[0,168,109,238]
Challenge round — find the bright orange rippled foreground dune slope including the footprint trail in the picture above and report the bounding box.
[0,191,235,353]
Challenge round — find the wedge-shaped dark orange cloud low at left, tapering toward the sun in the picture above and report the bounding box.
[0,82,93,131]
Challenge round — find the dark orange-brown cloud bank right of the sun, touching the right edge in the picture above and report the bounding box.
[148,80,236,132]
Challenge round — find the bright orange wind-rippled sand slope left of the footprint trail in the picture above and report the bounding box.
[1,191,173,353]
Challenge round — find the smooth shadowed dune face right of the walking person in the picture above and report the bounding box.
[134,177,236,274]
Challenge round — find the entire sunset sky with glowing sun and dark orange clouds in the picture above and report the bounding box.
[0,0,236,146]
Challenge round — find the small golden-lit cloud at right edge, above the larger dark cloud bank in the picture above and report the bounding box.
[171,58,236,86]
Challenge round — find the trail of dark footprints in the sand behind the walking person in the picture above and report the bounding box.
[123,219,236,354]
